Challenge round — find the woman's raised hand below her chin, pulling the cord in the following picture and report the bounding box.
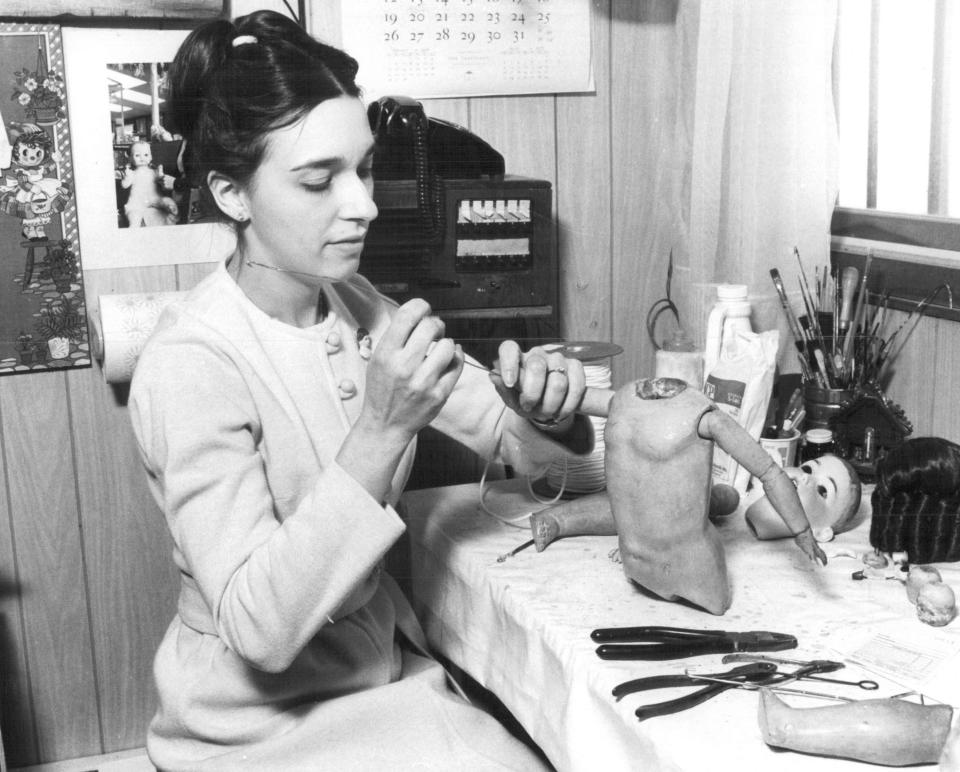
[361,298,463,442]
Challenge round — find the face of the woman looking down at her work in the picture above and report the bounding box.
[240,96,377,280]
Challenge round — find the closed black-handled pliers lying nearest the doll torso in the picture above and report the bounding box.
[590,626,797,660]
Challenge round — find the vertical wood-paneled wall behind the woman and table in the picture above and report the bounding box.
[0,0,960,766]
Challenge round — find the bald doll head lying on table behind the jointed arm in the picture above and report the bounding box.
[746,455,860,541]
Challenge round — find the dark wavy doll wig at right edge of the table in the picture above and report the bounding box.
[870,437,960,563]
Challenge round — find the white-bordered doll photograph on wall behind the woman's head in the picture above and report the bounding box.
[63,28,235,270]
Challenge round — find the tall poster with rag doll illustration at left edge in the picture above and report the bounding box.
[0,23,91,375]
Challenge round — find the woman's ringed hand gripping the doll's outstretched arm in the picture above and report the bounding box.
[491,340,587,427]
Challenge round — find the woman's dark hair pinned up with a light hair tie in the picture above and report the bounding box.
[166,11,360,187]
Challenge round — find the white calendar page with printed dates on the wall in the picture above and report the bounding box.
[341,0,593,99]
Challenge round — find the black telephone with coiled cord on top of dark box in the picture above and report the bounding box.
[367,96,504,242]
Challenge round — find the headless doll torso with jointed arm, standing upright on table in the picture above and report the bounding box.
[556,378,826,614]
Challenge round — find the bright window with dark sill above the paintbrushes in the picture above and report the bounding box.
[833,0,960,318]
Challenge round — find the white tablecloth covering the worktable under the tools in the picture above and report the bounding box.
[404,480,960,772]
